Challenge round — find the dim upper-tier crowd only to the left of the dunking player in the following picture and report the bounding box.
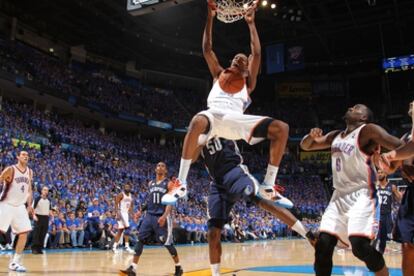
[0,38,191,127]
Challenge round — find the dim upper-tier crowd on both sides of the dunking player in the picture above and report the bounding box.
[0,35,330,135]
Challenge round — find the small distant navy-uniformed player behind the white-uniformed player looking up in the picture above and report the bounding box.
[377,170,402,253]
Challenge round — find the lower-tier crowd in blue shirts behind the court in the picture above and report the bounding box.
[0,99,328,251]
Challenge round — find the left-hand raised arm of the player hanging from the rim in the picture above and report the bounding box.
[203,0,223,79]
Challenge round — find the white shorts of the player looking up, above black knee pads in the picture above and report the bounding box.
[320,188,380,247]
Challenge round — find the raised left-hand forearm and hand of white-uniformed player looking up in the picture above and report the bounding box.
[300,128,340,151]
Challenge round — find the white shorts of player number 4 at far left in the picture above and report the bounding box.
[0,202,32,234]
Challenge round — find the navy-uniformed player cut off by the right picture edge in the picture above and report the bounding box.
[383,102,414,276]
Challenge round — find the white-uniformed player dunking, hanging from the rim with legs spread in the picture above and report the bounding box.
[162,0,289,204]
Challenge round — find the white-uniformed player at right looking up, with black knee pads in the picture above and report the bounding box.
[301,104,402,276]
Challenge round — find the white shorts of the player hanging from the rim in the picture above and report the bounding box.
[197,109,269,145]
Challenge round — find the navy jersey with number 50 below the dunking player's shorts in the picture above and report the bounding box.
[201,137,243,182]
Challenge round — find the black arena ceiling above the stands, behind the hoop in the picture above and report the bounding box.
[0,0,414,74]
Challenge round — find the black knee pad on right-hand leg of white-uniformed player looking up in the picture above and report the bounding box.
[349,237,385,272]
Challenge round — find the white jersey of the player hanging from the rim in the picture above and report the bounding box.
[207,80,252,114]
